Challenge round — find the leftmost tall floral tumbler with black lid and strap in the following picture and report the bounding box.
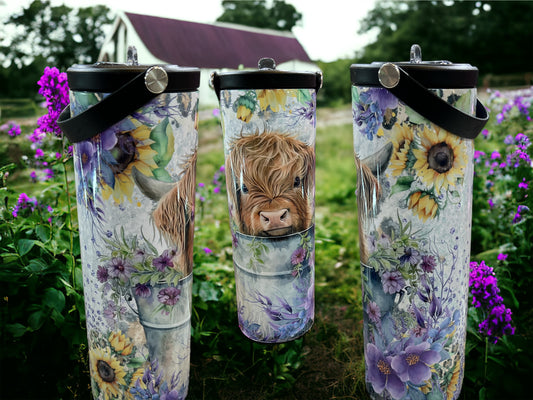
[60,63,200,399]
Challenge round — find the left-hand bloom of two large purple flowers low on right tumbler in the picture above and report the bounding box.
[365,343,407,399]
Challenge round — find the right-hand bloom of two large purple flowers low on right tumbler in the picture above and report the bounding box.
[391,342,441,385]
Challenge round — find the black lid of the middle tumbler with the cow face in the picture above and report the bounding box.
[211,58,322,96]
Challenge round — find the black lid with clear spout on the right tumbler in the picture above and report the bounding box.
[350,44,478,89]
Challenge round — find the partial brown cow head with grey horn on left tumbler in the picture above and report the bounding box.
[132,152,196,276]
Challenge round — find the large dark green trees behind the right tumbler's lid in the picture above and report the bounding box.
[359,0,533,74]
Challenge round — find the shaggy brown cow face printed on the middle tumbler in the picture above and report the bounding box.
[226,132,315,236]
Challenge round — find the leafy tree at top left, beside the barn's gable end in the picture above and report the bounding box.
[0,0,112,70]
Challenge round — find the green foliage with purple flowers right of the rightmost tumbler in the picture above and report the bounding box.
[463,92,533,399]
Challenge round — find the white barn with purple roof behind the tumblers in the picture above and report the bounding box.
[98,12,319,108]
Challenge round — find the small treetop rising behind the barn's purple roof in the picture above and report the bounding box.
[217,0,302,31]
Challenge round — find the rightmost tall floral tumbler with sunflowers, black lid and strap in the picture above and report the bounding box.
[350,45,488,399]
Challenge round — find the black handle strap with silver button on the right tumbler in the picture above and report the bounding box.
[378,63,489,139]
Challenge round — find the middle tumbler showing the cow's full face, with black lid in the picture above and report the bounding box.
[212,59,322,343]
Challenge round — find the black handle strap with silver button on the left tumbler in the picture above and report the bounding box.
[57,66,168,143]
